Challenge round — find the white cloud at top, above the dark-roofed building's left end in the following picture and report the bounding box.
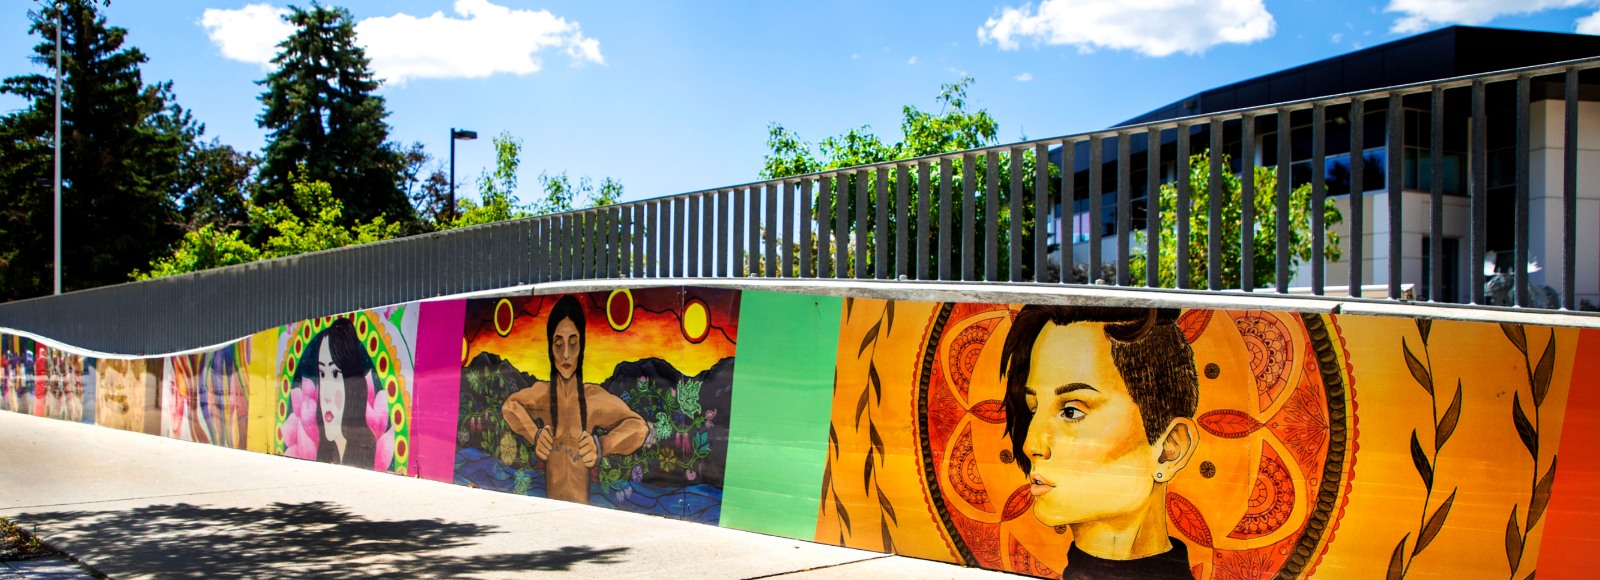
[978,0,1277,56]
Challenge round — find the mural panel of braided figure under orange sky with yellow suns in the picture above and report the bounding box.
[456,288,739,524]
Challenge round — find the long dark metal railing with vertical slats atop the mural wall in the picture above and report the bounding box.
[0,58,1600,354]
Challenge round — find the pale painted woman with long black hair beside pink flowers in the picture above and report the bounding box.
[282,317,395,471]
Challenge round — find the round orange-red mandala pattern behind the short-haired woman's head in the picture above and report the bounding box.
[914,303,1355,580]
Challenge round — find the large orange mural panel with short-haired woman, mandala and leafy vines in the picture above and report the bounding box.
[816,300,1594,580]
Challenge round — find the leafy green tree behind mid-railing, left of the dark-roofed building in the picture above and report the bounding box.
[760,77,1056,279]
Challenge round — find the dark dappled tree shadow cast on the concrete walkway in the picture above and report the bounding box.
[24,501,629,578]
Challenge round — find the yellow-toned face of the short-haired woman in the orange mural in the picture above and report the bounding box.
[1022,324,1162,526]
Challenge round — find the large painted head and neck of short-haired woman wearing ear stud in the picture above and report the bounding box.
[1000,306,1200,580]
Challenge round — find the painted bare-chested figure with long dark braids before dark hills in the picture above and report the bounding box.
[501,296,646,503]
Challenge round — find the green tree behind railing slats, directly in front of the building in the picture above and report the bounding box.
[1128,151,1344,288]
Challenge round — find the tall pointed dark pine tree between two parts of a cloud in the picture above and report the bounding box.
[254,2,413,223]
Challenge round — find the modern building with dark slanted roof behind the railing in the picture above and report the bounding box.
[1051,26,1600,303]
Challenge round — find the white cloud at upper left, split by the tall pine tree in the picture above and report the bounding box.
[200,0,605,83]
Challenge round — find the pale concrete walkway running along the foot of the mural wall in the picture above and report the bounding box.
[0,412,1019,580]
